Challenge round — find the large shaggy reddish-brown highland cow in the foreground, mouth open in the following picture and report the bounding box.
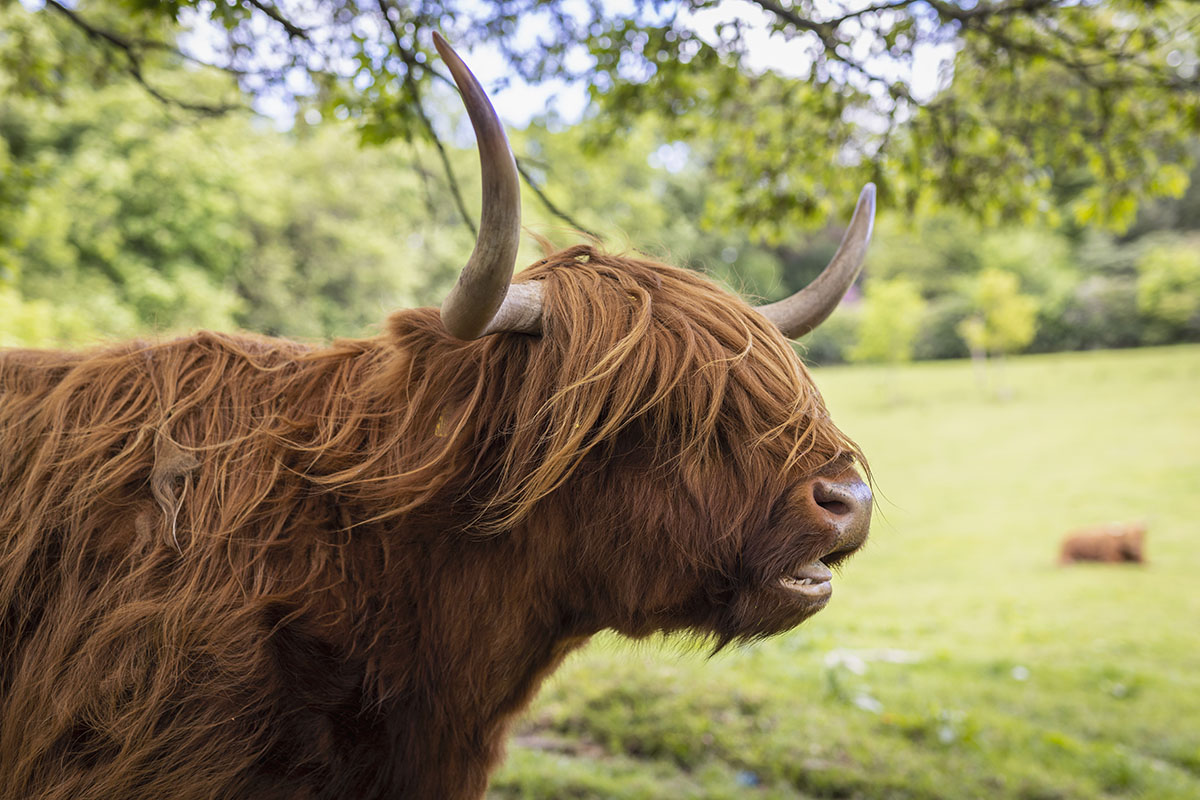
[0,34,874,800]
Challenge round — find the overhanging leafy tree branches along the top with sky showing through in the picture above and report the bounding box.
[6,0,1200,237]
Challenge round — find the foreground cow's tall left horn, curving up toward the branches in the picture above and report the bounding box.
[433,34,541,339]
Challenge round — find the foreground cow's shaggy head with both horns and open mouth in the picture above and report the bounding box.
[417,37,875,642]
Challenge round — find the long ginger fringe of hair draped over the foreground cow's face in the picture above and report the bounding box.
[319,246,865,534]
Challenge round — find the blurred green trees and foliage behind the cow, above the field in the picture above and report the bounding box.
[0,0,1200,363]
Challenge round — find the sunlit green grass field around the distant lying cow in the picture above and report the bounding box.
[488,347,1200,800]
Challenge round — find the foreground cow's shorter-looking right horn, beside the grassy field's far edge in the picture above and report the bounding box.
[757,184,875,339]
